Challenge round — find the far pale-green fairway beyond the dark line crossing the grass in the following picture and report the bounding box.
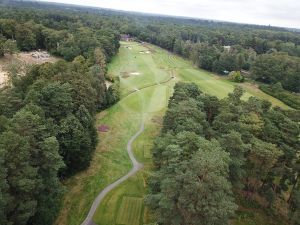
[109,42,289,109]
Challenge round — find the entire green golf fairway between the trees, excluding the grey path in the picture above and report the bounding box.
[56,42,288,225]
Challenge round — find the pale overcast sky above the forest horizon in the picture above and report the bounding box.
[37,0,300,28]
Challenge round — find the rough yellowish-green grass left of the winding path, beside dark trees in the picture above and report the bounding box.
[56,104,142,225]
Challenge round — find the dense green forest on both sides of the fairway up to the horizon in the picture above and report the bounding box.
[0,1,300,225]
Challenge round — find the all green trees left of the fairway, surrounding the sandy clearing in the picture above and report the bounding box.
[0,3,119,225]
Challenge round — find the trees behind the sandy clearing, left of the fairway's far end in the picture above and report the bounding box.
[0,8,119,61]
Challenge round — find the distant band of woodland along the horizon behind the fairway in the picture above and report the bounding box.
[0,1,300,95]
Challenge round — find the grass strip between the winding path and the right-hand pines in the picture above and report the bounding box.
[93,114,163,225]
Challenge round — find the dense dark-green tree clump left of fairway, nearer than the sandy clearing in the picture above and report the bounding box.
[0,57,113,224]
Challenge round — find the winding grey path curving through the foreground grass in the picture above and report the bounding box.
[81,122,145,225]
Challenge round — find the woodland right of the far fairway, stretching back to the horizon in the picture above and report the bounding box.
[120,15,300,92]
